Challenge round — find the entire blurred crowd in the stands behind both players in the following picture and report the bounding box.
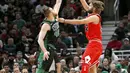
[0,0,130,73]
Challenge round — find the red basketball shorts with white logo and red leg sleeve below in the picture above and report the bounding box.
[81,41,103,73]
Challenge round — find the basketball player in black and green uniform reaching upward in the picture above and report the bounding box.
[36,0,62,73]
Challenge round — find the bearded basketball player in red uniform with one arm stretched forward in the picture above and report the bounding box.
[58,0,104,73]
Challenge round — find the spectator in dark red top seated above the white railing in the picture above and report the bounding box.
[107,34,122,50]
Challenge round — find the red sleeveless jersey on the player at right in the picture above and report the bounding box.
[85,14,102,40]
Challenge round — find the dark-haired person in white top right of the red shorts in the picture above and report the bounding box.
[100,48,119,65]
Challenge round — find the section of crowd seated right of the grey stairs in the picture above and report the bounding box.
[99,12,130,73]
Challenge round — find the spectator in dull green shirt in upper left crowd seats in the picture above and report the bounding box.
[13,13,26,30]
